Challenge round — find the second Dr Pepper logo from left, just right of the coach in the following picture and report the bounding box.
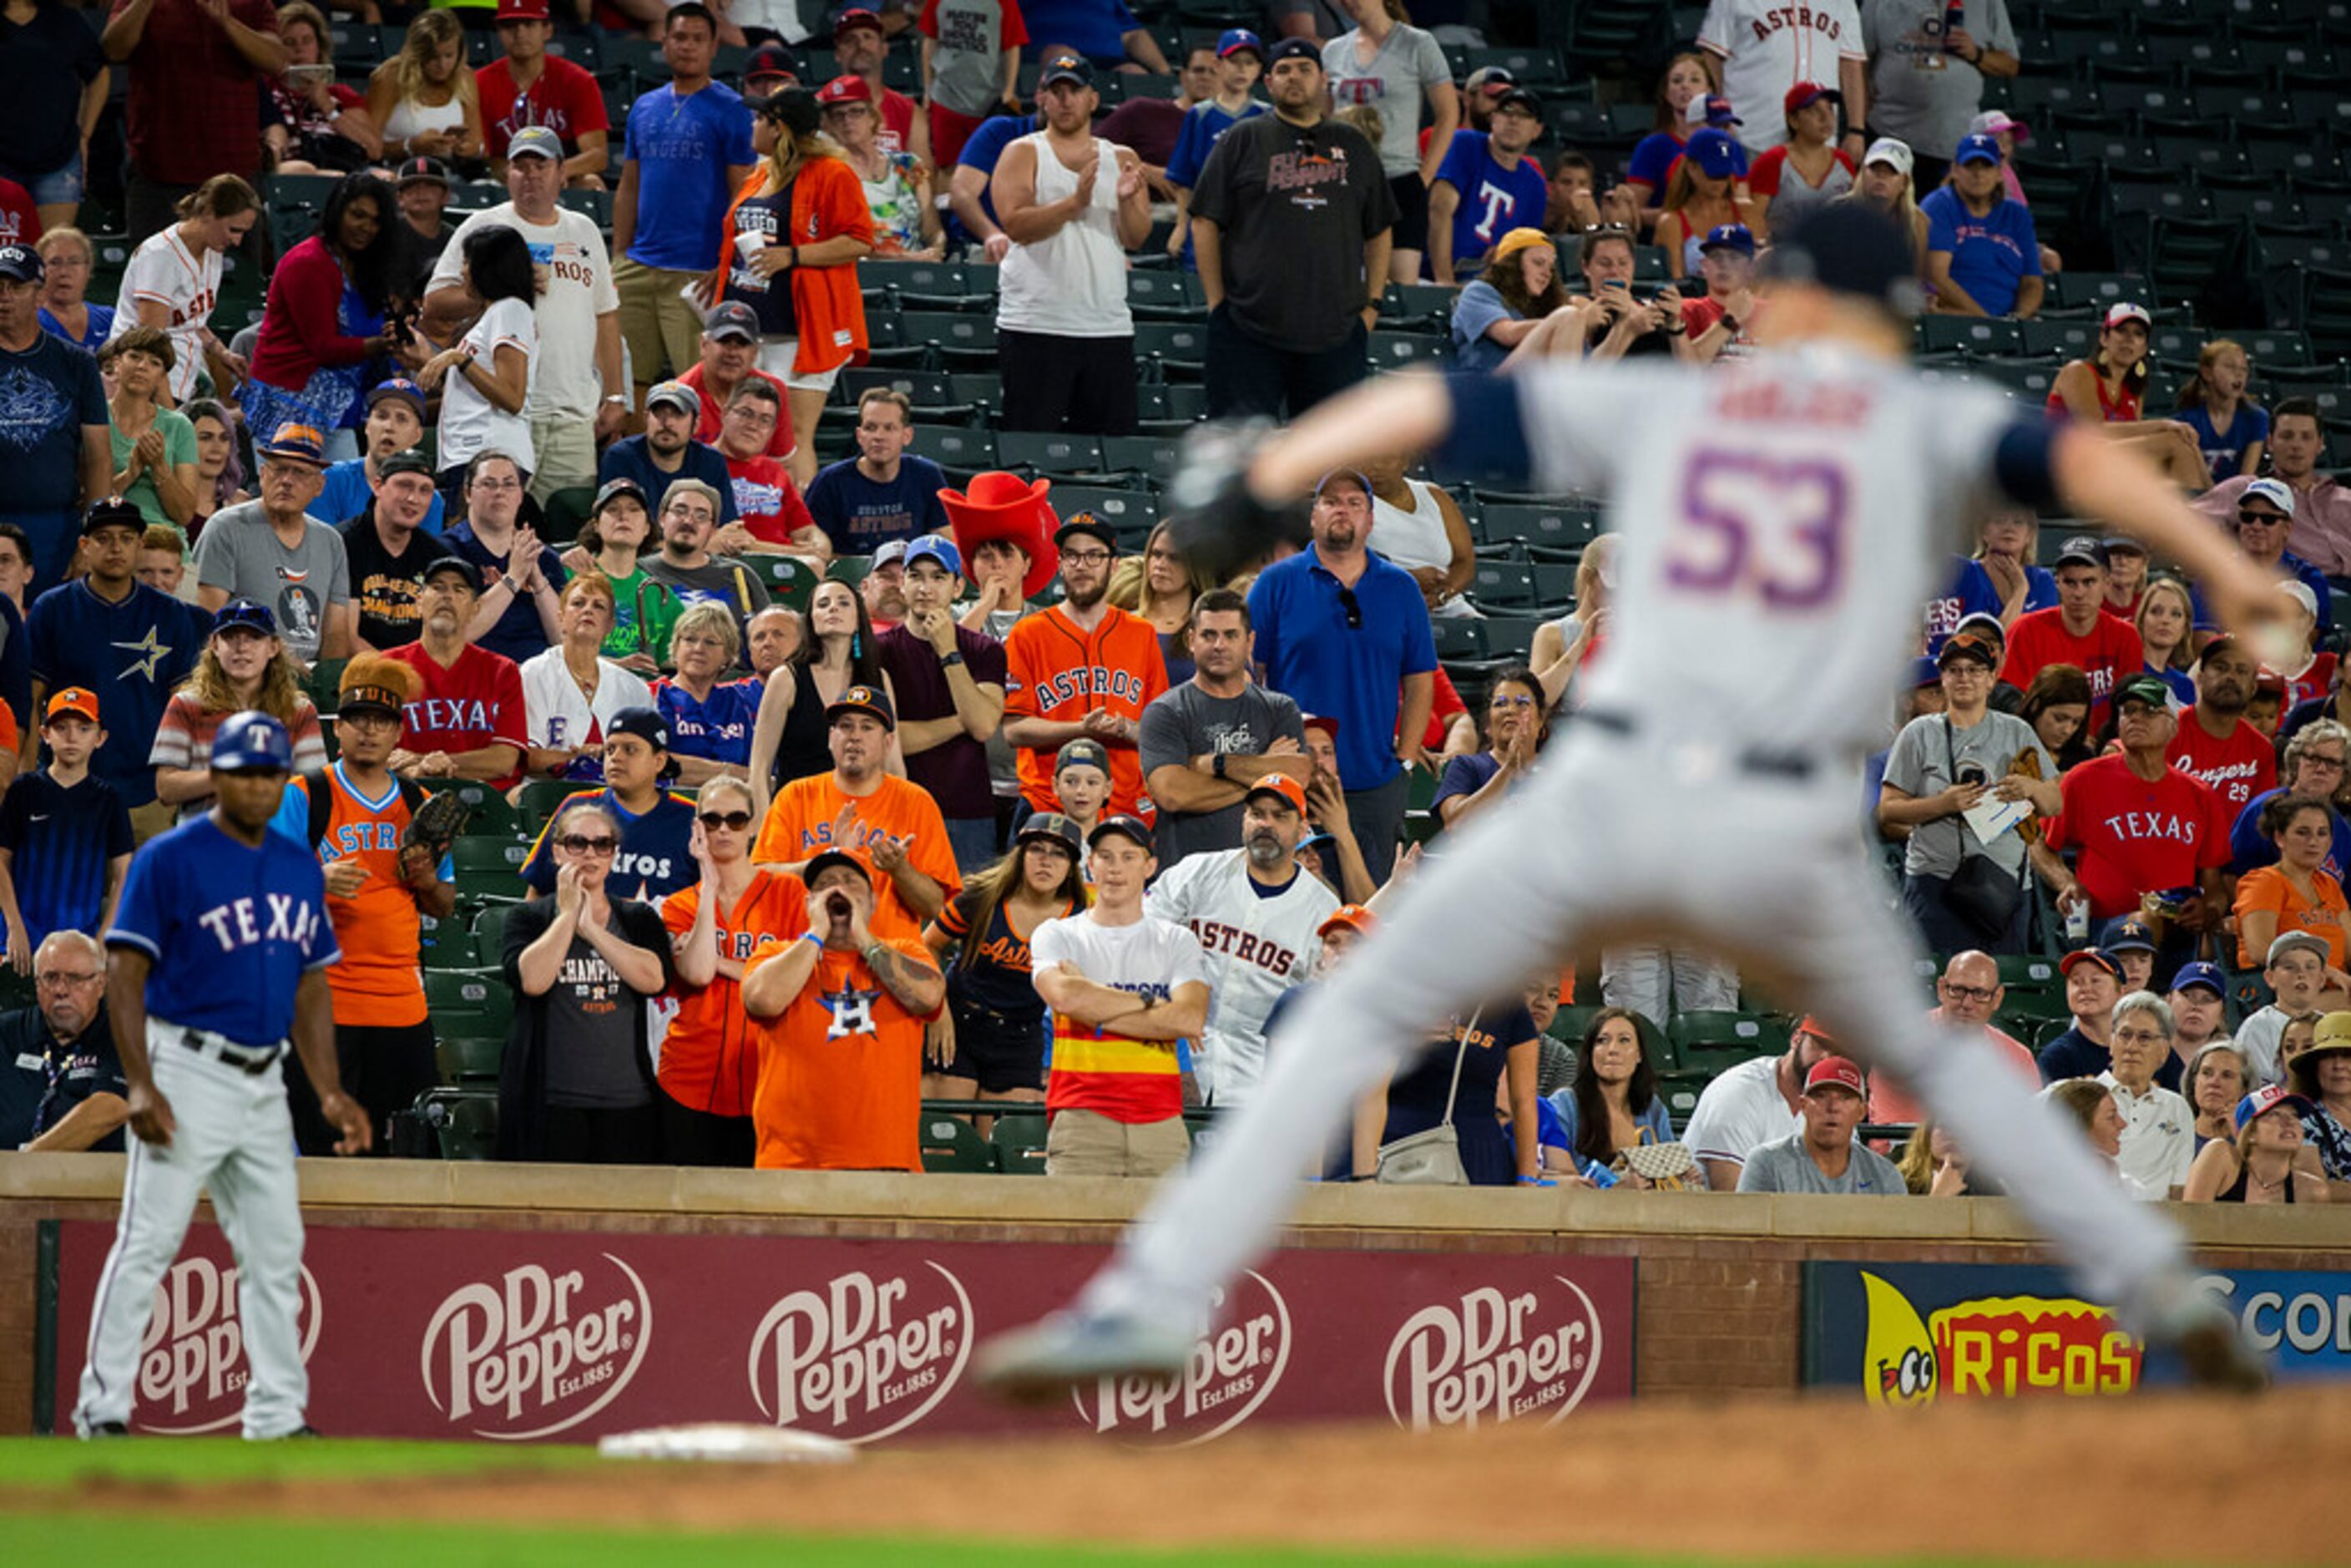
[421,1253,654,1444]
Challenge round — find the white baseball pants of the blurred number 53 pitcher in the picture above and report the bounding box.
[1081,726,2182,1326]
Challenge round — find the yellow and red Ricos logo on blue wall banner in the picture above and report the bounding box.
[1862,1269,2140,1406]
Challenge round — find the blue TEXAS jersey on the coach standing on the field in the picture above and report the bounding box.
[106,813,343,1046]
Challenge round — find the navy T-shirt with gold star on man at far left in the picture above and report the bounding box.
[26,579,211,811]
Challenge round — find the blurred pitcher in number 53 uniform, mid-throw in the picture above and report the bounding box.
[980,202,2278,1396]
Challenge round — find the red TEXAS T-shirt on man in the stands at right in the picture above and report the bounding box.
[2045,755,2231,919]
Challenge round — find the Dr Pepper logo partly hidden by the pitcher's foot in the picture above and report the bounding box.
[1069,1272,1291,1448]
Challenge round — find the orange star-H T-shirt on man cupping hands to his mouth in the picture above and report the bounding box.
[743,936,938,1171]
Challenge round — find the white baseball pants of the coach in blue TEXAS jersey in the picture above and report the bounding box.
[73,1020,311,1439]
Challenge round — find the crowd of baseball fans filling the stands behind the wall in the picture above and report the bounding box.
[0,0,2351,1201]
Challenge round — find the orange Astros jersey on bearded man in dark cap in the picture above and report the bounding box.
[1004,604,1169,821]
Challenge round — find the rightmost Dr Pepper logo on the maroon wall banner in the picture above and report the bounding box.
[1385,1274,1604,1432]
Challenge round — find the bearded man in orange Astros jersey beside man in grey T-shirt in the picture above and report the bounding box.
[1004,513,1165,816]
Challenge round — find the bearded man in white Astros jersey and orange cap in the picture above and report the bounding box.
[1143,773,1337,1105]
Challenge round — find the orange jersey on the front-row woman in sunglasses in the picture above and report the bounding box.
[656,865,809,1116]
